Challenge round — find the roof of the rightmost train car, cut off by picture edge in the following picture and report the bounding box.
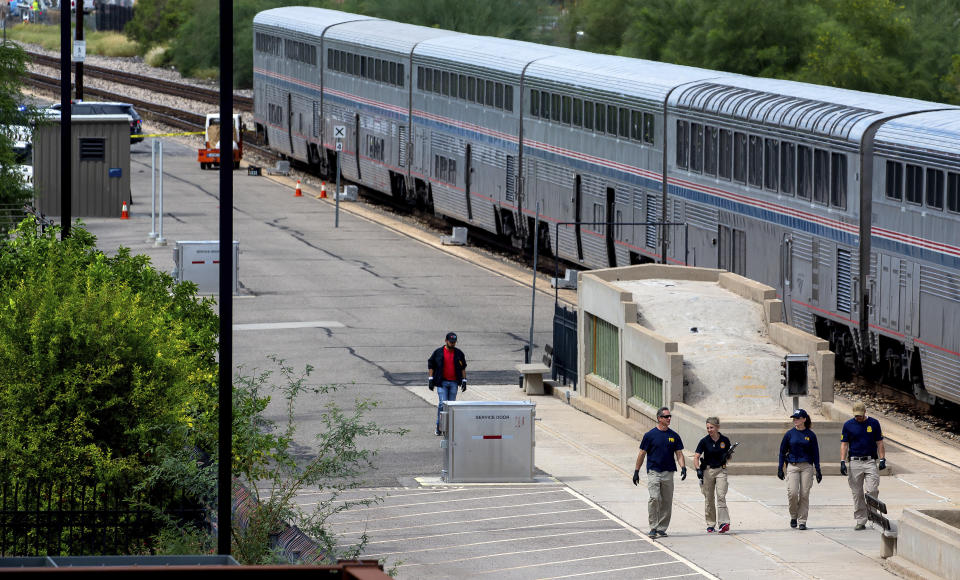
[875,105,960,160]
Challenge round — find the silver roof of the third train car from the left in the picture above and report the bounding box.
[414,34,574,75]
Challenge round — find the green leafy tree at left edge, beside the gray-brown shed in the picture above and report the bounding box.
[0,42,38,218]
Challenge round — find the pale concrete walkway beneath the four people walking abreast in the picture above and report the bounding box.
[411,385,960,580]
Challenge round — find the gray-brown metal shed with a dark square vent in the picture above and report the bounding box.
[33,115,132,218]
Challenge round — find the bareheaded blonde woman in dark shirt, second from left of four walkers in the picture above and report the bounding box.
[693,417,733,534]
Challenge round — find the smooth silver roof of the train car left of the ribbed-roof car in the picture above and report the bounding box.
[527,50,727,104]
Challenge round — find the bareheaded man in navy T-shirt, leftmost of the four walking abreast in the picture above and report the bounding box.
[633,407,687,538]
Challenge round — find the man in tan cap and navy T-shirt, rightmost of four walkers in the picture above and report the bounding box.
[840,401,887,530]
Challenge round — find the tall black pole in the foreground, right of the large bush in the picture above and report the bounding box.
[217,0,233,555]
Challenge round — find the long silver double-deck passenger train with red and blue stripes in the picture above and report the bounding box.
[253,7,960,403]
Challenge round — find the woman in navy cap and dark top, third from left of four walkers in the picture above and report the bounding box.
[777,409,823,530]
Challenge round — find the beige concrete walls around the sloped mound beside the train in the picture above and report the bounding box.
[575,264,843,473]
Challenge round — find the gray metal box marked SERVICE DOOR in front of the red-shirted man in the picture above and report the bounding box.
[441,401,537,483]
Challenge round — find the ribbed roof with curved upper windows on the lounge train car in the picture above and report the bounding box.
[670,76,944,141]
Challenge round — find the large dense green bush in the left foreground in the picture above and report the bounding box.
[0,218,218,481]
